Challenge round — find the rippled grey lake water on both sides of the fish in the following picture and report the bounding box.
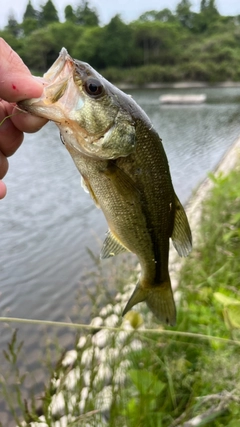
[0,88,240,422]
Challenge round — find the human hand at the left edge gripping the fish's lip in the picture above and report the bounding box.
[0,38,47,199]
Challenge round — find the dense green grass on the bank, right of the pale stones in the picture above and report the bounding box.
[122,170,240,427]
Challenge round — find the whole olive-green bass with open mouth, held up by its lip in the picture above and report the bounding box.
[18,48,192,325]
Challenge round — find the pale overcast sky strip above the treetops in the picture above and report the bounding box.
[0,0,240,29]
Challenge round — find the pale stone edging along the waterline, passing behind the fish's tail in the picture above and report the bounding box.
[12,136,240,427]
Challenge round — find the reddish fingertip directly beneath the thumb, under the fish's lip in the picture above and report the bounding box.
[11,107,47,133]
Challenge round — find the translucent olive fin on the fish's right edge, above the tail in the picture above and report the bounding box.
[171,195,192,256]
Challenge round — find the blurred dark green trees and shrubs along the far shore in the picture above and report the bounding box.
[0,0,240,84]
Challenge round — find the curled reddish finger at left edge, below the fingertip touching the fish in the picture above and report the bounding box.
[0,101,23,157]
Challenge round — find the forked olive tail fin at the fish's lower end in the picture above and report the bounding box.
[123,280,176,326]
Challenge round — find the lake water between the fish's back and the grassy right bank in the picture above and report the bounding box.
[133,88,240,203]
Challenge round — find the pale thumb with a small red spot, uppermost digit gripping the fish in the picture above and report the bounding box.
[0,38,43,102]
